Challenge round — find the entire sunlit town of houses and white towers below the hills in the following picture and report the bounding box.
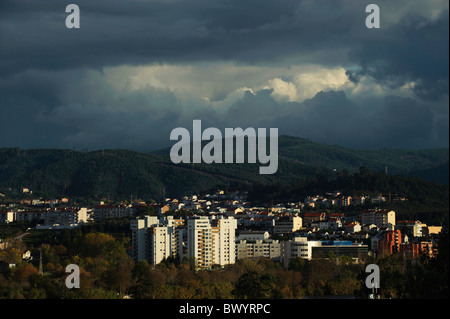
[0,188,442,269]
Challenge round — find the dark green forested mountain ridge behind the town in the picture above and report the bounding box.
[0,136,449,199]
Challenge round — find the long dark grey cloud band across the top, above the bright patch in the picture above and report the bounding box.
[0,0,380,73]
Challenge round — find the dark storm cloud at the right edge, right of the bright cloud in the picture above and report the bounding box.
[349,11,449,99]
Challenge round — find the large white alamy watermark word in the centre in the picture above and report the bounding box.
[170,120,278,174]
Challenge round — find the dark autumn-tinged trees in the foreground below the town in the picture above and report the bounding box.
[0,230,449,299]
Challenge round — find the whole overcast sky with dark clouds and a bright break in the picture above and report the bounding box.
[0,0,449,150]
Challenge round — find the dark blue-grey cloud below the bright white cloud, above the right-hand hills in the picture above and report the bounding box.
[221,91,442,148]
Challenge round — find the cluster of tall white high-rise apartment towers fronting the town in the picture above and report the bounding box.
[130,216,237,269]
